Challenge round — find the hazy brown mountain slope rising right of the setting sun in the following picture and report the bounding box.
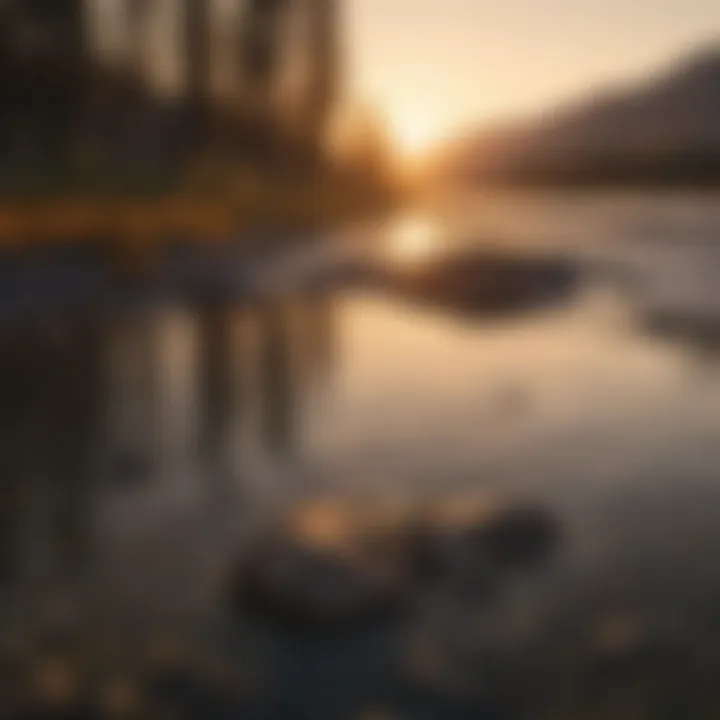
[436,41,720,184]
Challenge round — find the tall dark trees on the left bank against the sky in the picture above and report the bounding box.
[0,0,335,184]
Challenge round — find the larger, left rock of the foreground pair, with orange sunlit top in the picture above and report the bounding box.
[231,503,410,631]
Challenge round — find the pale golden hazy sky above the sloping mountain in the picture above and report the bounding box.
[345,0,720,146]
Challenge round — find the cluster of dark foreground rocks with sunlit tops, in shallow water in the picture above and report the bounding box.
[230,496,558,629]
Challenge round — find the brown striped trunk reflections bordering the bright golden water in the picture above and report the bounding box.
[191,294,335,474]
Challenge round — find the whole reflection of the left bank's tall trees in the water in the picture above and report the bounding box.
[0,296,333,584]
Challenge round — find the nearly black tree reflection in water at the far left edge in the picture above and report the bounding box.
[0,317,104,572]
